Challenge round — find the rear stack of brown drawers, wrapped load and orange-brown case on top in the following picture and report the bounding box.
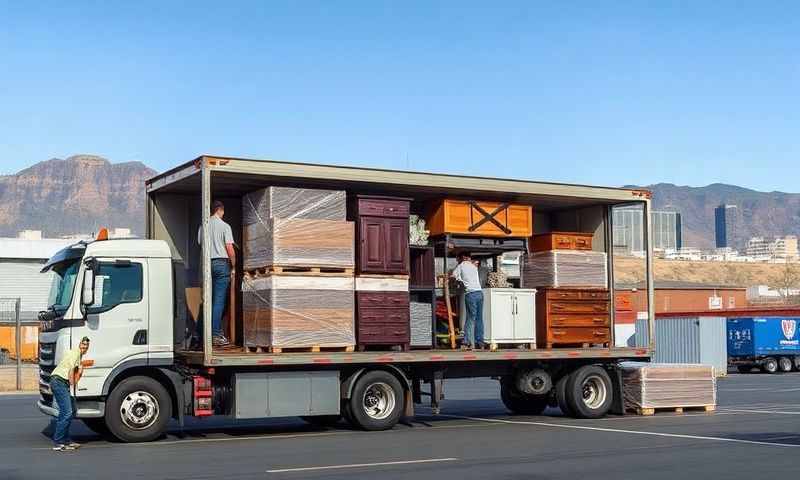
[520,232,611,348]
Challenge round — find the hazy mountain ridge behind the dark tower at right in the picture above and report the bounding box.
[644,183,800,249]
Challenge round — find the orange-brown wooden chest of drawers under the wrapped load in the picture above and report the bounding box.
[536,288,611,348]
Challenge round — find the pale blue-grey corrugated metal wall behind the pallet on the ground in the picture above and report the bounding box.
[635,317,728,375]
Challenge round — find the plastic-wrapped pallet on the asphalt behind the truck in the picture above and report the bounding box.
[621,362,717,410]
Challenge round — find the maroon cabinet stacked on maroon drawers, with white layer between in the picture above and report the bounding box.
[350,195,411,349]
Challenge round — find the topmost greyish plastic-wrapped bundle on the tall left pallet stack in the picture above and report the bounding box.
[242,187,347,225]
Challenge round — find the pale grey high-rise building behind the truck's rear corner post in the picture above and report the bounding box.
[612,206,683,255]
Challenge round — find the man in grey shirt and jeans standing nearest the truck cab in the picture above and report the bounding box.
[197,200,236,347]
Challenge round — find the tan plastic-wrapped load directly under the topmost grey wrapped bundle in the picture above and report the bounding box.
[244,218,355,270]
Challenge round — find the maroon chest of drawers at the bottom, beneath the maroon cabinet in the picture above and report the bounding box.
[356,292,411,350]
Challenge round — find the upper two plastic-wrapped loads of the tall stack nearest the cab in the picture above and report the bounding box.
[242,187,355,270]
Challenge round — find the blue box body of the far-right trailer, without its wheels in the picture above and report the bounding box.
[728,317,800,357]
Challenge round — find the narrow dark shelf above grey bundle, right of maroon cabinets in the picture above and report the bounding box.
[409,245,436,348]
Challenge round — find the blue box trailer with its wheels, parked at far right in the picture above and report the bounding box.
[728,317,800,373]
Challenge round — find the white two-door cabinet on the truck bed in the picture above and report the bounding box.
[460,288,536,344]
